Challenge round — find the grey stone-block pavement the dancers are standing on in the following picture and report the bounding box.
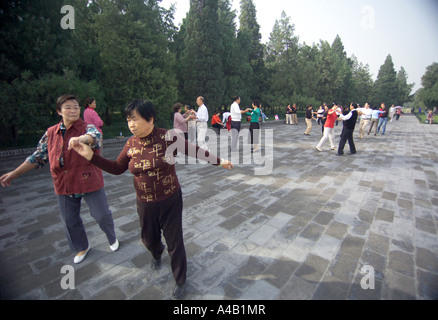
[0,116,438,300]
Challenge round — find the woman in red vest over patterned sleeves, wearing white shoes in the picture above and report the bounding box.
[0,95,119,264]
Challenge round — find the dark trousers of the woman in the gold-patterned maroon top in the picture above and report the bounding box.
[137,189,187,285]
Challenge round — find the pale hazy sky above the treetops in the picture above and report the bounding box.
[161,0,438,93]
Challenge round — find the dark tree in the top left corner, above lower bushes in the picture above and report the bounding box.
[0,0,78,82]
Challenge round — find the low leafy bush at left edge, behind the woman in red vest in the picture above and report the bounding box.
[0,70,103,146]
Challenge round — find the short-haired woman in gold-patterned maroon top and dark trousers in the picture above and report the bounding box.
[70,100,233,299]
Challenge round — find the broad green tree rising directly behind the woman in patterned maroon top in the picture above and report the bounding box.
[95,0,177,126]
